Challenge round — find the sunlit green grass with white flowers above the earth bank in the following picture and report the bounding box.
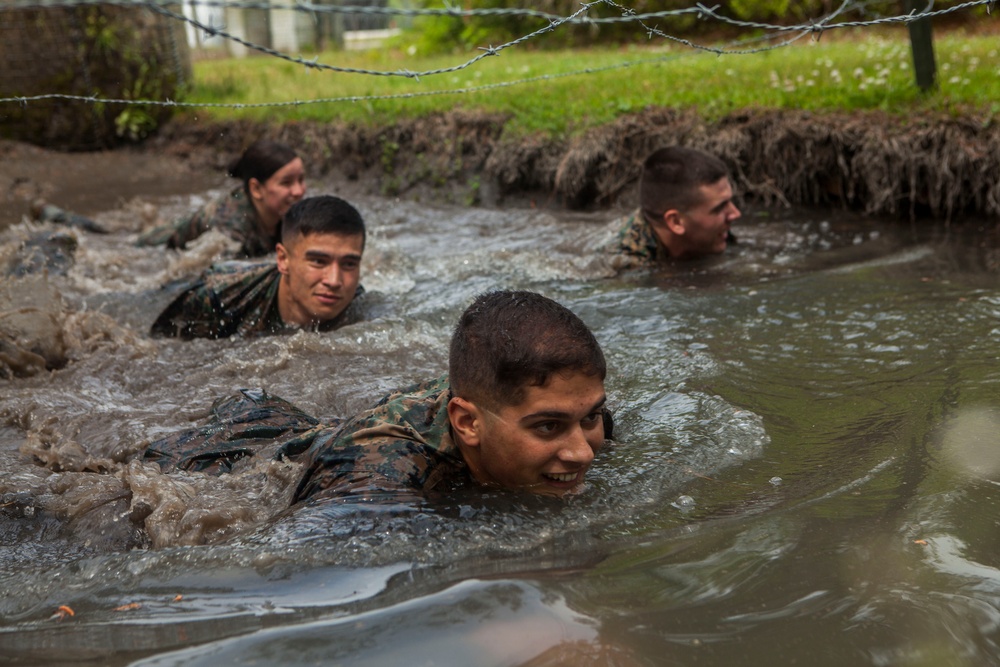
[186,28,1000,136]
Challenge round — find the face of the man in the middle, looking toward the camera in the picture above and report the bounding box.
[276,234,364,326]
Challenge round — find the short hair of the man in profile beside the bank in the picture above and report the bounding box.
[639,146,729,218]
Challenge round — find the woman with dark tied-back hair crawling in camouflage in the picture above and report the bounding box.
[139,139,306,258]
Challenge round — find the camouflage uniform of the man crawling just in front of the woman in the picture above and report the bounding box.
[152,262,364,338]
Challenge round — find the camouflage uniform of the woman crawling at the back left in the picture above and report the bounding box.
[138,185,280,258]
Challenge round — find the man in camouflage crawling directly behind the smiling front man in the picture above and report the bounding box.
[152,195,365,338]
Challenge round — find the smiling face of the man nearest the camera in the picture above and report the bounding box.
[453,371,605,496]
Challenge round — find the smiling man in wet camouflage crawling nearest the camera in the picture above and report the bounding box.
[145,291,613,504]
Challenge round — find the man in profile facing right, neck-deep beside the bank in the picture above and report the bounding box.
[610,146,740,269]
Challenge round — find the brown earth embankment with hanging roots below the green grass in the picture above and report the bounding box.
[146,109,1000,221]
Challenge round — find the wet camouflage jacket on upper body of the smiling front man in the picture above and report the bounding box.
[292,375,469,502]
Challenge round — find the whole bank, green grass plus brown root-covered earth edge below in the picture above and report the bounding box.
[152,28,1000,222]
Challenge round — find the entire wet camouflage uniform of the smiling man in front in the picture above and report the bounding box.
[143,376,469,502]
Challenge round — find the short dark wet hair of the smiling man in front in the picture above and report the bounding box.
[448,291,607,407]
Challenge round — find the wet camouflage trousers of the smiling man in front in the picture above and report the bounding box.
[143,389,338,475]
